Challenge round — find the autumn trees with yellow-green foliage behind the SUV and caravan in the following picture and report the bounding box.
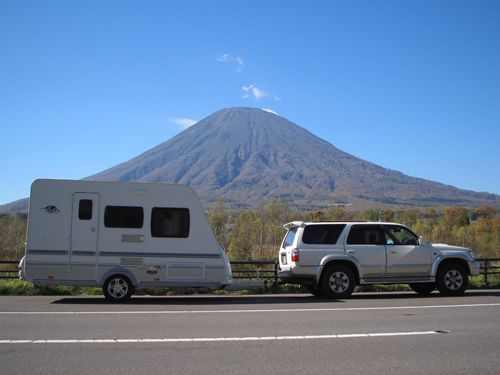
[0,203,500,260]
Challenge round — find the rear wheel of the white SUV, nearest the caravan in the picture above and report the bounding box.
[320,265,356,299]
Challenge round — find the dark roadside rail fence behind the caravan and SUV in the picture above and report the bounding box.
[0,258,500,289]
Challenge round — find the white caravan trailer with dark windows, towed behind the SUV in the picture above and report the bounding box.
[20,180,232,302]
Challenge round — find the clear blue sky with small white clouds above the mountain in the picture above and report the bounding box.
[0,0,500,204]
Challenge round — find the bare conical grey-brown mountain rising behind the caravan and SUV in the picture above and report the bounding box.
[89,108,500,207]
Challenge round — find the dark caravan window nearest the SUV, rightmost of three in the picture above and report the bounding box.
[151,207,190,238]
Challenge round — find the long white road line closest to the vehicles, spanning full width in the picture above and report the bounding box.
[0,303,500,315]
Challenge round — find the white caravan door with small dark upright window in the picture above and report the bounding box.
[69,193,99,279]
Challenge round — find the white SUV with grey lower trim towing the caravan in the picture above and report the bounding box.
[279,221,479,298]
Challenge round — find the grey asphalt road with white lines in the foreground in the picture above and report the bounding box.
[0,290,500,375]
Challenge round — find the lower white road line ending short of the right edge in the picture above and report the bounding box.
[0,331,449,344]
